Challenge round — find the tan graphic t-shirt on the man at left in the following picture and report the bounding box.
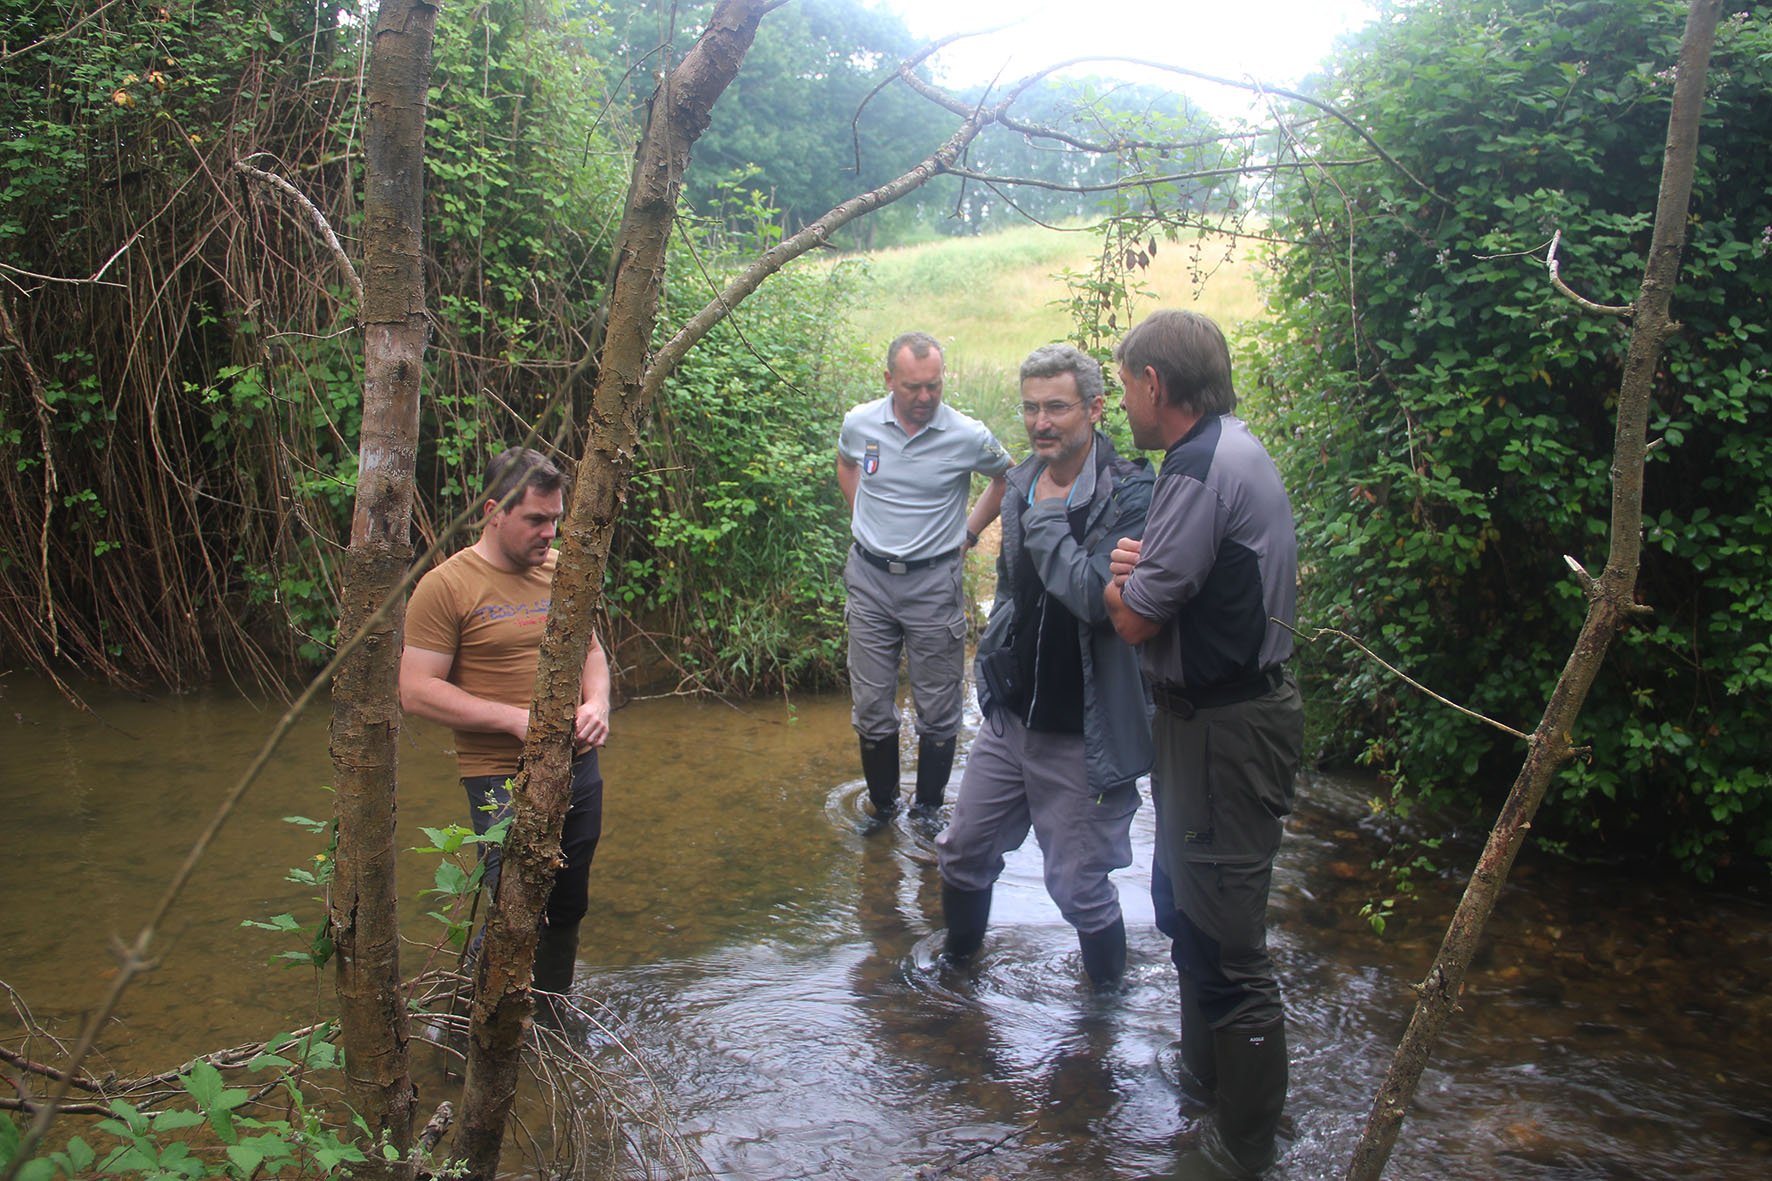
[406,548,560,778]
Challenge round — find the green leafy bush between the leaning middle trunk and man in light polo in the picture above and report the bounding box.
[608,209,875,693]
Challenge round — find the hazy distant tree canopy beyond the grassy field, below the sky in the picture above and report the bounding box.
[601,0,1221,248]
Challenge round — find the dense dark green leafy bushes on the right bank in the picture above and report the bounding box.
[1256,0,1772,876]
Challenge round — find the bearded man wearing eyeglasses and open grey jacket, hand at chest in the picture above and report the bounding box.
[936,344,1154,989]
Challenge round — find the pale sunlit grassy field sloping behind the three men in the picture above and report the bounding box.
[826,225,1262,438]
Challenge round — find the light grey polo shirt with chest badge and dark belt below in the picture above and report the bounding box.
[836,394,1012,562]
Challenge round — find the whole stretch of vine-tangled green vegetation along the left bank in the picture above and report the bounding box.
[0,0,864,688]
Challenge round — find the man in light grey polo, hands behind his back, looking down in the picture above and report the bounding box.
[836,332,1010,823]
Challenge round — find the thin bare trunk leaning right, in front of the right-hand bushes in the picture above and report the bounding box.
[1347,0,1722,1181]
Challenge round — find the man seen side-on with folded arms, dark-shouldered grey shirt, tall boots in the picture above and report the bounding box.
[1102,310,1304,1174]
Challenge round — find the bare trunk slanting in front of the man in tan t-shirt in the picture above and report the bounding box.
[459,0,769,1179]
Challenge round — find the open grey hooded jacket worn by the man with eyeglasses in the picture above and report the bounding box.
[976,431,1155,794]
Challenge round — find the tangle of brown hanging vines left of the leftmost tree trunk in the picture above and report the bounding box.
[0,0,347,683]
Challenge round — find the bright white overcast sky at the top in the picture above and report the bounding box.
[872,0,1373,108]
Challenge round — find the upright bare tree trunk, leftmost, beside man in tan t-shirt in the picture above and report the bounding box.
[331,0,438,1177]
